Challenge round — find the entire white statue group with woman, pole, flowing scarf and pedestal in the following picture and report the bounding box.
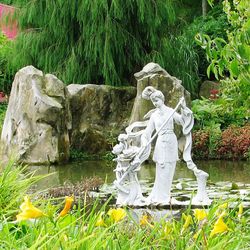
[112,86,211,206]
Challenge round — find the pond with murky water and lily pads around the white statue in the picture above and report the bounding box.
[30,160,250,220]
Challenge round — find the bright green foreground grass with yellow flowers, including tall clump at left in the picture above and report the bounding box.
[0,159,250,250]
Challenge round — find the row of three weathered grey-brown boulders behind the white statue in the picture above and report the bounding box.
[1,63,190,161]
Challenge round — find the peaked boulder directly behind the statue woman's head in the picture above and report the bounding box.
[130,62,191,123]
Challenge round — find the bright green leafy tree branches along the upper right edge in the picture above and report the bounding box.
[196,0,250,129]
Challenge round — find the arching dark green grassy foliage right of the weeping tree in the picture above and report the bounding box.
[155,4,228,97]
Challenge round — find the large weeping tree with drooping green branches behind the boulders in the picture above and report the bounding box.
[9,0,175,86]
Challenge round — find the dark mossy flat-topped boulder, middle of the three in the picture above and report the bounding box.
[67,84,136,153]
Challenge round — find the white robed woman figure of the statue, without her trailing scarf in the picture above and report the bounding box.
[141,86,186,205]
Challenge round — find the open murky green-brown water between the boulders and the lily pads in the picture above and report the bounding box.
[30,160,250,189]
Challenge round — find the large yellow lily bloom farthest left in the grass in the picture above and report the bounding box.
[16,196,45,221]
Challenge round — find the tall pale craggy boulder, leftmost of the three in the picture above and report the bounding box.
[1,66,71,164]
